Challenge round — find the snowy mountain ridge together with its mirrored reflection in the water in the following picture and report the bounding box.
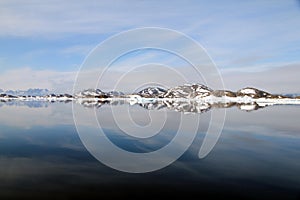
[0,84,300,113]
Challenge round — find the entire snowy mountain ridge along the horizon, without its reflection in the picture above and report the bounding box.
[0,83,300,100]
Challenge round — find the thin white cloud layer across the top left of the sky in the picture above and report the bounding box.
[0,0,193,36]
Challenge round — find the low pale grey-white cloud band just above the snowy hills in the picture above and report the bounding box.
[0,63,300,93]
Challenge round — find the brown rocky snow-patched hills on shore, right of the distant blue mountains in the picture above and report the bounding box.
[68,83,300,102]
